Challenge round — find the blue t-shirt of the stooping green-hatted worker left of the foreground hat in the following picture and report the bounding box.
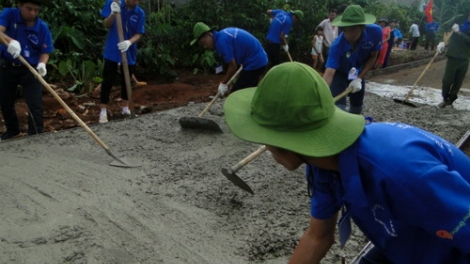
[212,28,268,71]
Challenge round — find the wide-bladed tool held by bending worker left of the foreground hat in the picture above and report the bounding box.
[179,66,243,132]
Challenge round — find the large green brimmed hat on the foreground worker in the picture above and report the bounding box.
[224,62,365,157]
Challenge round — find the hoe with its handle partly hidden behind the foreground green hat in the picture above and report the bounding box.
[222,87,353,194]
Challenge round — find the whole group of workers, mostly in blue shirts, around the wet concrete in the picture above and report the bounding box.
[0,0,470,264]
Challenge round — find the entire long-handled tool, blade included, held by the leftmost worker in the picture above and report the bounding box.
[1,35,140,168]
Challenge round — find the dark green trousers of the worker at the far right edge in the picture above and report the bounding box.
[442,57,469,103]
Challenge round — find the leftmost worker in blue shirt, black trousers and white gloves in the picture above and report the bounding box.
[0,0,54,140]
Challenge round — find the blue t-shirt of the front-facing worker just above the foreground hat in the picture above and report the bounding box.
[326,24,382,74]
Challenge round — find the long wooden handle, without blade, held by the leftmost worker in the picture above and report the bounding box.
[0,34,110,153]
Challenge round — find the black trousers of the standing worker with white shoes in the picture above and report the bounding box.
[100,59,135,104]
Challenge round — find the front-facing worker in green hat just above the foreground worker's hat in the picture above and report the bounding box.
[323,5,382,114]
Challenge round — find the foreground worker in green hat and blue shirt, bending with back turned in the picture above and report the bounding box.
[224,62,470,264]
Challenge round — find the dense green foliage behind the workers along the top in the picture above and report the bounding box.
[0,0,470,89]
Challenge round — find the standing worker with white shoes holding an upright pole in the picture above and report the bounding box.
[99,0,145,123]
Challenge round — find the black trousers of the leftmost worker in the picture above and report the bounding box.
[0,61,44,135]
